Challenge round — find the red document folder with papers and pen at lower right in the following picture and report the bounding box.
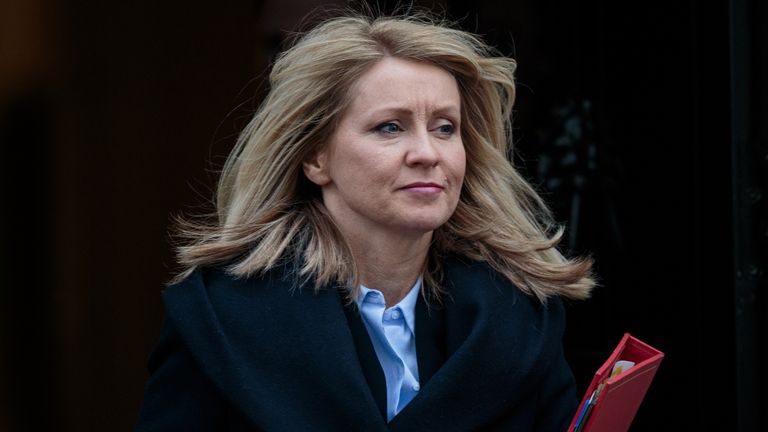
[568,333,664,432]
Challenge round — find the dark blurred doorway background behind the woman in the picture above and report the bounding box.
[0,0,768,431]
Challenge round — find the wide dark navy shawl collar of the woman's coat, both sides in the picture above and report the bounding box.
[165,260,559,431]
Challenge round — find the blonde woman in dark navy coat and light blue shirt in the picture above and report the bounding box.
[137,11,593,431]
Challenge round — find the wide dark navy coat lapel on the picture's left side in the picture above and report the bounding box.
[165,271,386,431]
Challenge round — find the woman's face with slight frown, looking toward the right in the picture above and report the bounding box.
[304,57,465,239]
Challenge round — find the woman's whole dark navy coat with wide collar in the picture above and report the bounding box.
[136,255,577,431]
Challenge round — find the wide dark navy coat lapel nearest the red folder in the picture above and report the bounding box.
[389,260,559,431]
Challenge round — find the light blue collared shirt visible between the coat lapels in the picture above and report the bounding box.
[355,277,422,421]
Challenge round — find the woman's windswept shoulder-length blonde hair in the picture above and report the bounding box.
[177,15,594,302]
